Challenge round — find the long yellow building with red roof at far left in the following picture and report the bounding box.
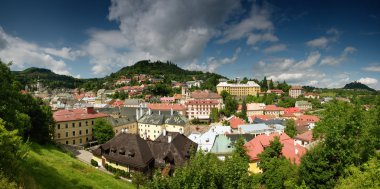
[53,107,109,145]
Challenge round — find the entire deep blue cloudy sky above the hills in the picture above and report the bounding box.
[0,0,380,89]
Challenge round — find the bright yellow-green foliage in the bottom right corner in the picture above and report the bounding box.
[335,157,380,189]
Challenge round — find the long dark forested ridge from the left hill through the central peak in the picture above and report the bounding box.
[12,60,225,90]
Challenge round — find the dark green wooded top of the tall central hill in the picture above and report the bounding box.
[106,60,225,81]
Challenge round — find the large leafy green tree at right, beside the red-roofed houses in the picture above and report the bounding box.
[299,101,377,188]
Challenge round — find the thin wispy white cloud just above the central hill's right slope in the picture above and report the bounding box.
[186,48,241,72]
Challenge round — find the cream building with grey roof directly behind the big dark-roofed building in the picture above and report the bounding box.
[137,110,189,140]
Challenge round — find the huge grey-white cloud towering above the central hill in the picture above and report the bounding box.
[83,0,239,75]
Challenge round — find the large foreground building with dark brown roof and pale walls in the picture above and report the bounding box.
[92,133,197,175]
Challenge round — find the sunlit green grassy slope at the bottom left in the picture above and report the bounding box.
[23,143,135,189]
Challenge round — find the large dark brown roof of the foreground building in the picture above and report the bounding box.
[93,132,198,168]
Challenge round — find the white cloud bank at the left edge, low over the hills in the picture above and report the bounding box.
[0,27,71,75]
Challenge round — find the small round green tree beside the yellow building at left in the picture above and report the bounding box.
[93,119,115,144]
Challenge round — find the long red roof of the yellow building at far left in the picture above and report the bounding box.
[53,108,108,122]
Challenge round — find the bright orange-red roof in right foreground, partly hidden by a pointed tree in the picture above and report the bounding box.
[244,133,306,164]
